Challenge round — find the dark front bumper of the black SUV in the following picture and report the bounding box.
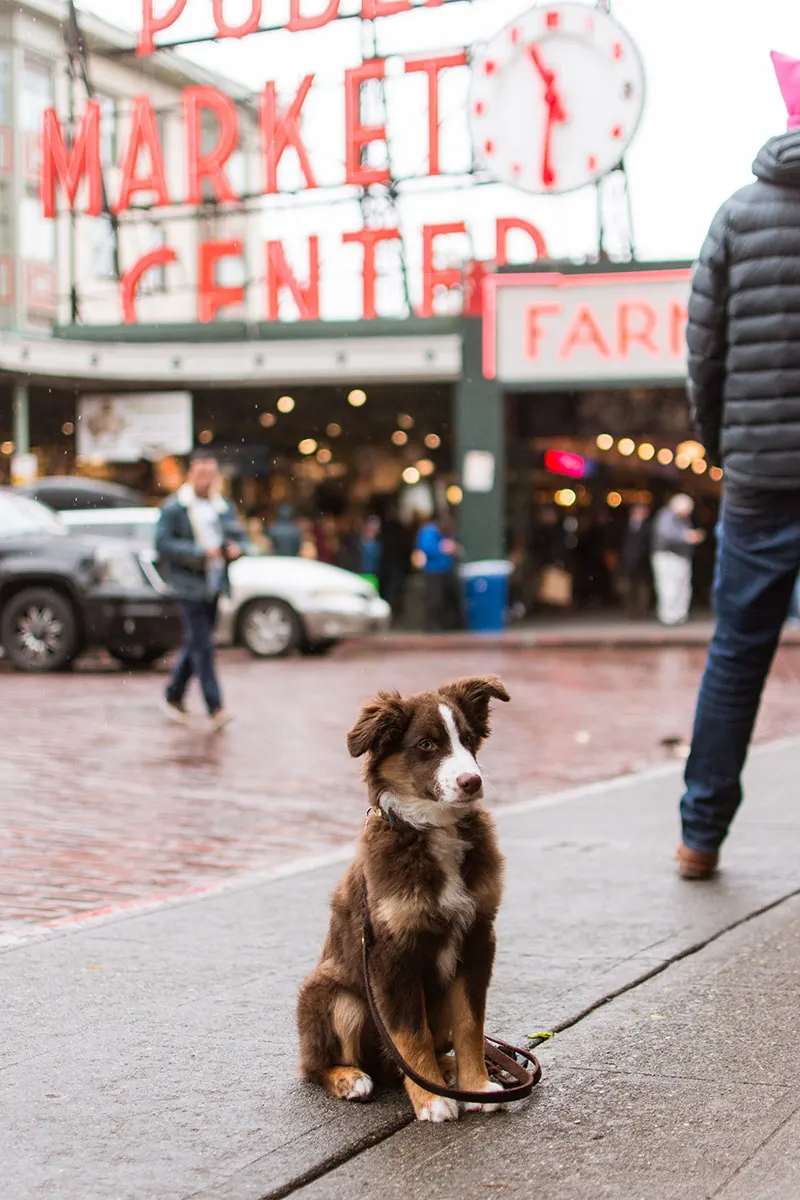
[84,588,184,649]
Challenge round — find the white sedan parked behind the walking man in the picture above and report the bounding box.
[60,509,391,659]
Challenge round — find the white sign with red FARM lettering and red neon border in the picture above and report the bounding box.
[483,268,692,384]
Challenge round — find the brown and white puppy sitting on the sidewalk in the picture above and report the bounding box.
[297,676,509,1122]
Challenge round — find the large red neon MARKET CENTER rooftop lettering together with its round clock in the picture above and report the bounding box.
[41,0,643,323]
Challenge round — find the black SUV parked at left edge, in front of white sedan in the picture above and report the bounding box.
[0,487,181,671]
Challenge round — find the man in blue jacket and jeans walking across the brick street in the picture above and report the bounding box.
[156,450,247,731]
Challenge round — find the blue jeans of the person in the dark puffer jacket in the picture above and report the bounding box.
[680,498,800,851]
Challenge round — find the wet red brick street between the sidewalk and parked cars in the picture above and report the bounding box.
[0,647,800,936]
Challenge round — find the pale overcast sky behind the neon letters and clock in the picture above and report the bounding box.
[74,0,800,314]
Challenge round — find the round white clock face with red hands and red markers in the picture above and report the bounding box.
[469,4,644,193]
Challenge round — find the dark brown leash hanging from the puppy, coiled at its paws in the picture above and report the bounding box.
[361,880,542,1104]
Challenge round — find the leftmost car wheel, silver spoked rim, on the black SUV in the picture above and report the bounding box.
[0,588,78,671]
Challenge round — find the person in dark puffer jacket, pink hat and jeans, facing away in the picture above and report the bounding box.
[678,53,800,878]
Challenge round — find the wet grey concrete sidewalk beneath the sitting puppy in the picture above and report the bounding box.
[0,740,800,1200]
